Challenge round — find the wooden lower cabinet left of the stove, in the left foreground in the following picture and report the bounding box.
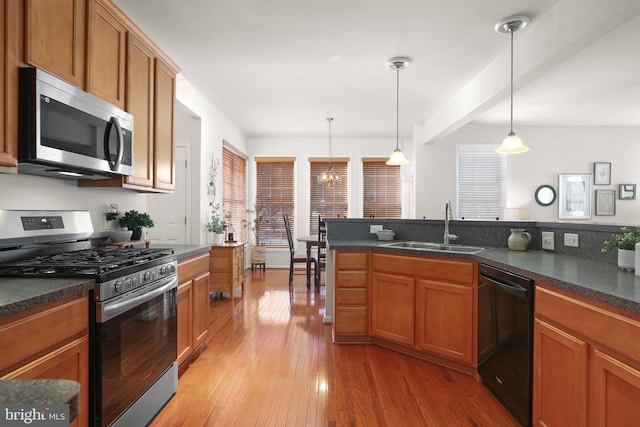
[0,292,89,427]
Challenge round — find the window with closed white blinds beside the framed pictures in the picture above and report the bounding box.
[457,145,507,220]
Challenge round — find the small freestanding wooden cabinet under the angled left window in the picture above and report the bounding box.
[209,242,244,298]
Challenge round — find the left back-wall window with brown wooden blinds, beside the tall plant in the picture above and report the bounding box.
[255,157,295,246]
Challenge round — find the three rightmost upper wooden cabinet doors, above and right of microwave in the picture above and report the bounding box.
[78,0,180,192]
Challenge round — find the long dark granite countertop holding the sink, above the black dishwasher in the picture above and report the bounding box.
[329,240,640,314]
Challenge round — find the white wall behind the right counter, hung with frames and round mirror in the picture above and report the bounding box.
[416,125,640,224]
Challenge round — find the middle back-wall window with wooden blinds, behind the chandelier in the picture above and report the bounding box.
[309,158,349,236]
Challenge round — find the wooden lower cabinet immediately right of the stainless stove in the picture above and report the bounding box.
[178,253,210,367]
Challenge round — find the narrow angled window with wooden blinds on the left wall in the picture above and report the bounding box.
[222,145,247,242]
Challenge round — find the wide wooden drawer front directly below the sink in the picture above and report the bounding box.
[371,253,477,286]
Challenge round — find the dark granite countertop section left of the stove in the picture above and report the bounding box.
[0,277,95,318]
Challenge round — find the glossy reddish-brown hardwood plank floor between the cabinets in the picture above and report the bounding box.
[152,270,518,427]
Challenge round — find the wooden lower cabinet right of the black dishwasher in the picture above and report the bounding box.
[533,283,640,427]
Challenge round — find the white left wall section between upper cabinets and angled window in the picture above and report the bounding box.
[176,75,247,243]
